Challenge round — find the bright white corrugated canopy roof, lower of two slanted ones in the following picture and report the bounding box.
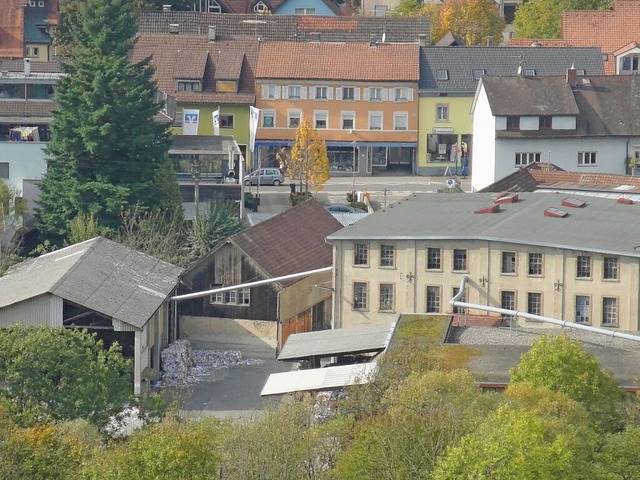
[260,362,378,397]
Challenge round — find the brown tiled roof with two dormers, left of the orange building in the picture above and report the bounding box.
[131,34,258,104]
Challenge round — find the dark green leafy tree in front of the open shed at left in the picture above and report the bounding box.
[0,326,131,425]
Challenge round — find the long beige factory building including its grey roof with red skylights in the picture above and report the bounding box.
[328,193,640,331]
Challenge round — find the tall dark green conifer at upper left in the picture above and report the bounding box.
[38,0,170,243]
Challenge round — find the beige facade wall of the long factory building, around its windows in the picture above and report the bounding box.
[334,239,640,330]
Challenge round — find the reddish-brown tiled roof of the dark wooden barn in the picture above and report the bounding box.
[229,199,342,284]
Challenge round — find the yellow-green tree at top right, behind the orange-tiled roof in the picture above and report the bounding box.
[513,0,613,38]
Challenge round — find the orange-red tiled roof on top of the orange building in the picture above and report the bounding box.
[256,42,420,82]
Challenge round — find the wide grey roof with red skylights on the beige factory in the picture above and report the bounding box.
[327,193,640,257]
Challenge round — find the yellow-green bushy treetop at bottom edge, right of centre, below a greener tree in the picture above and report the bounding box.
[432,406,593,480]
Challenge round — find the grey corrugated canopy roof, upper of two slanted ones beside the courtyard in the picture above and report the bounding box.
[278,322,396,360]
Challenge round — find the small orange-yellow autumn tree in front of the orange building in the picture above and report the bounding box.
[284,115,329,193]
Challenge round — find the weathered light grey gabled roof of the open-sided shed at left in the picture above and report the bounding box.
[0,237,182,328]
